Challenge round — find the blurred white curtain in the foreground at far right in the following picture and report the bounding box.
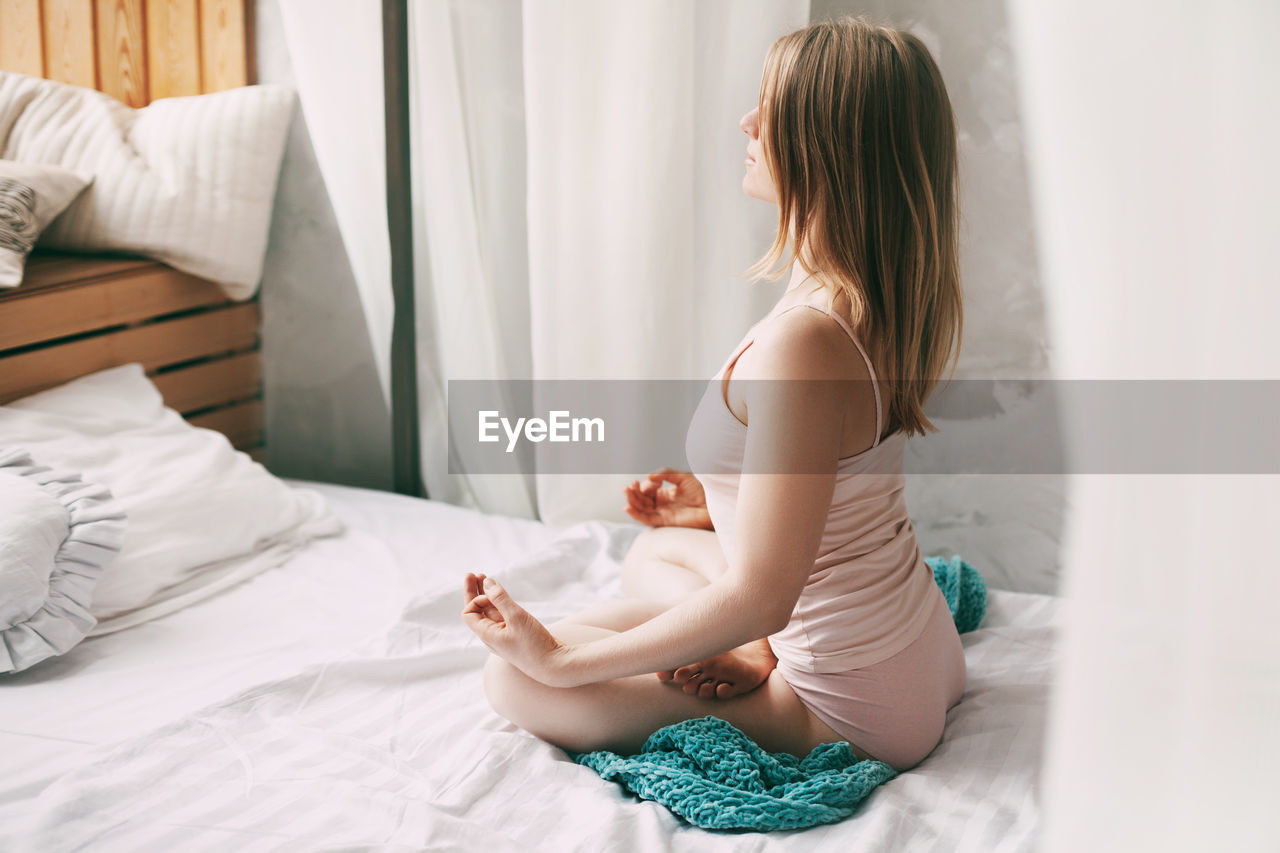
[1010,0,1280,852]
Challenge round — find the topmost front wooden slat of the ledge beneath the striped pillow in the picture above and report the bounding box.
[0,265,229,350]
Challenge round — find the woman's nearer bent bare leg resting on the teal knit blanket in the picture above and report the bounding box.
[484,624,841,756]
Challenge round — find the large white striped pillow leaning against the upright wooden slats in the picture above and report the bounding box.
[0,72,294,298]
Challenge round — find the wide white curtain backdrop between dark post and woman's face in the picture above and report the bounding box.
[410,0,809,524]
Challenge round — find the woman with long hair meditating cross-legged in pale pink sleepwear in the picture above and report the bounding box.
[463,18,965,771]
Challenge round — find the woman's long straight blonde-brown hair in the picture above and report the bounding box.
[746,17,964,435]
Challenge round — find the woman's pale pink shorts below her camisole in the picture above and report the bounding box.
[778,589,965,771]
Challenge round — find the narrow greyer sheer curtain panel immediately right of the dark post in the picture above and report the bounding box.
[410,0,536,517]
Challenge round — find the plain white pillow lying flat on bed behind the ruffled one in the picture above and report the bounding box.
[0,364,342,635]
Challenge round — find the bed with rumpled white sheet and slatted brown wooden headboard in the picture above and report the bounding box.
[0,0,1062,852]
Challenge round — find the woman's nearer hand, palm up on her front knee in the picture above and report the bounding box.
[462,573,568,686]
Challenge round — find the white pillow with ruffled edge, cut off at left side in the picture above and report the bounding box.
[0,447,125,672]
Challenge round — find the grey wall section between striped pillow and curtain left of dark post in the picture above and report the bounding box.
[255,0,392,488]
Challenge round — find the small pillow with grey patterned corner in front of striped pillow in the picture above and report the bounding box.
[0,160,92,287]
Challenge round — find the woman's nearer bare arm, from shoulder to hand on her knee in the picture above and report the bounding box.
[471,315,844,686]
